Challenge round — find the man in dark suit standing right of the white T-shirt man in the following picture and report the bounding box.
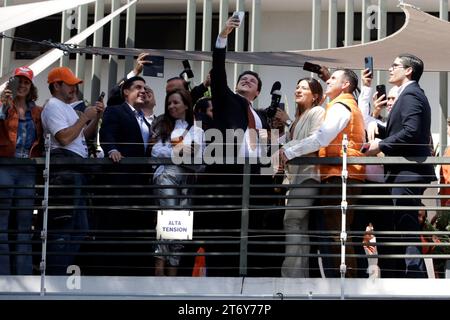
[99,76,154,275]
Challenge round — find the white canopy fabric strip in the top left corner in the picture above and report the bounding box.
[0,0,95,32]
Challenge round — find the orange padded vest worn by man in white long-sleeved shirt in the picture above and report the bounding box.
[319,93,366,181]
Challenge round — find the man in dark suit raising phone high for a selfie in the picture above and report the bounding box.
[206,17,281,276]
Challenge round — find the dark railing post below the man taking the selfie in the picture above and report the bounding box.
[239,158,251,276]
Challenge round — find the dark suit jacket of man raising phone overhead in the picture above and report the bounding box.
[211,48,269,131]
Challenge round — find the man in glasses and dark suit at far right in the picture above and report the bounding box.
[368,54,436,278]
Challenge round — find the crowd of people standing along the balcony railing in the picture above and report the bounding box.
[0,13,446,278]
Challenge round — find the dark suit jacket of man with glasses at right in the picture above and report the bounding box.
[379,82,436,183]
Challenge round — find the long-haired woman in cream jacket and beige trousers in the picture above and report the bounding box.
[275,78,325,278]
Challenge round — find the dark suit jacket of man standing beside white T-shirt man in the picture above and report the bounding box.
[100,102,150,157]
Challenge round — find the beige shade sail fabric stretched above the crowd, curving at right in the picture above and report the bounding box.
[61,4,450,71]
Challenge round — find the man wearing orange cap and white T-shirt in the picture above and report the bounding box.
[42,67,102,274]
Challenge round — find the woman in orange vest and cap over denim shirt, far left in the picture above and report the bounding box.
[0,67,43,275]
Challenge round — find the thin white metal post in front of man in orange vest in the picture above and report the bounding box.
[340,134,348,300]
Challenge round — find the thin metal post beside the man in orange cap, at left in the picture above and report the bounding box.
[39,134,51,296]
